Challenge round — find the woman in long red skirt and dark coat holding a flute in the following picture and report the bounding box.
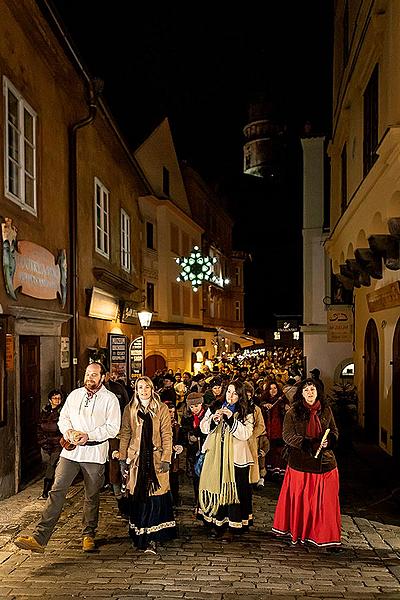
[272,379,341,551]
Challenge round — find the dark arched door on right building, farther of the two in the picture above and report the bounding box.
[364,319,379,444]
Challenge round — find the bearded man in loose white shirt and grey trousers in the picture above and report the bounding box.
[14,362,121,552]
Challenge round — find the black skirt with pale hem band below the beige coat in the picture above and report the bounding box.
[129,492,177,550]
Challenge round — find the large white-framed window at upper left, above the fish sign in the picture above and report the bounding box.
[4,78,36,214]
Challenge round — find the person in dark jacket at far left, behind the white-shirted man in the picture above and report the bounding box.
[37,388,63,500]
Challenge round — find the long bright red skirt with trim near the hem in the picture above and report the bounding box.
[272,467,341,547]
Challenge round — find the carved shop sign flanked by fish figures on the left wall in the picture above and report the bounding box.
[1,217,67,307]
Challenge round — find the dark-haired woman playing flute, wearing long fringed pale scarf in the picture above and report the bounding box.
[198,381,254,540]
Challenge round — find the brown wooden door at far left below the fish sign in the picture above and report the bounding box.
[19,335,42,485]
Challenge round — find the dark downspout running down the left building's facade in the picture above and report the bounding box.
[68,79,103,390]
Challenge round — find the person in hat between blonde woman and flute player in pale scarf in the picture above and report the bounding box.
[181,392,206,512]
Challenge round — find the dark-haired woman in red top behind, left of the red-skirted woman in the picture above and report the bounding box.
[259,381,289,486]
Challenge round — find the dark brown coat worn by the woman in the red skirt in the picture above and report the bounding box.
[283,406,339,473]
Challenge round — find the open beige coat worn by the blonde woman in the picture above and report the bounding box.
[119,403,172,496]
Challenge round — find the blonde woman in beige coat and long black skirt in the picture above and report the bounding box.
[119,377,176,554]
